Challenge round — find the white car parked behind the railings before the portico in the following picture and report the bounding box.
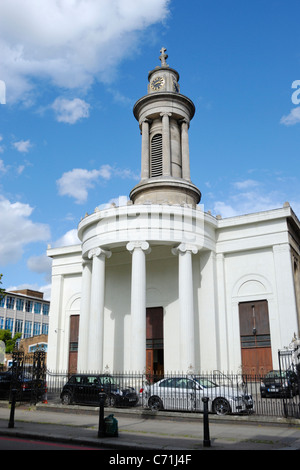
[142,376,254,415]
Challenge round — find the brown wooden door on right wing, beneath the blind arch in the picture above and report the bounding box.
[239,300,273,376]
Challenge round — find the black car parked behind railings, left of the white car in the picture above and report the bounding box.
[60,374,139,406]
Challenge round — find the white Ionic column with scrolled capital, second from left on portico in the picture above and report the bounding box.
[88,248,111,371]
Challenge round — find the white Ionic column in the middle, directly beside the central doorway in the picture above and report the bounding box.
[126,241,151,372]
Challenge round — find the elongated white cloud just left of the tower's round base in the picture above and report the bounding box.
[56,165,137,204]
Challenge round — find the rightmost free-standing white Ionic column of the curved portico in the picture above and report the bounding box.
[172,243,198,373]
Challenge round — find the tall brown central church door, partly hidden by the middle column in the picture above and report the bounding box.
[146,307,164,374]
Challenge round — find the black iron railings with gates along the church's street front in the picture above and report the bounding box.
[4,350,300,419]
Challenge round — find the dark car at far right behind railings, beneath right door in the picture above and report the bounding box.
[260,370,299,398]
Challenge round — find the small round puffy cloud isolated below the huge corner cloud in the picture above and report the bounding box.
[51,97,90,124]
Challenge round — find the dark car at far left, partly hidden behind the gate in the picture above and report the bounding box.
[0,370,47,401]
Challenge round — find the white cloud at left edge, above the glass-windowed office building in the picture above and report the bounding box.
[0,196,50,266]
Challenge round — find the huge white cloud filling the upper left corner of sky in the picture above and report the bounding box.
[0,0,170,102]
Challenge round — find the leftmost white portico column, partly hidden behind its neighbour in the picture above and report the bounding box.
[77,260,92,372]
